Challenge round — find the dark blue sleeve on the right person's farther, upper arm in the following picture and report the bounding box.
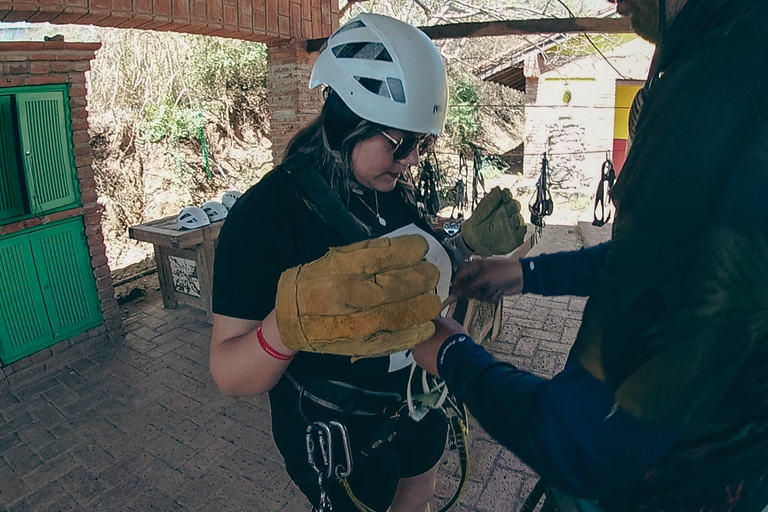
[520,242,611,297]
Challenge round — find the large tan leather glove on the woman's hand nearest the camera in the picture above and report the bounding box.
[276,235,442,357]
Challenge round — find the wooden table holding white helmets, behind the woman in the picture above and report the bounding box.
[128,215,224,322]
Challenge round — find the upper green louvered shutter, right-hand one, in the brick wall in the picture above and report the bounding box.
[16,91,77,214]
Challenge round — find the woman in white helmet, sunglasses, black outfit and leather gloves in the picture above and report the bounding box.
[210,14,525,512]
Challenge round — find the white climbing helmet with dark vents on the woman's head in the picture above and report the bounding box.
[309,14,448,135]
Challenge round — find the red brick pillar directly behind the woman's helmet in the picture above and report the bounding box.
[267,39,322,164]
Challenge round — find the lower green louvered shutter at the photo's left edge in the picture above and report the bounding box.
[0,230,53,364]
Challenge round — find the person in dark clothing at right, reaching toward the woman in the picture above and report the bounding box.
[414,0,768,512]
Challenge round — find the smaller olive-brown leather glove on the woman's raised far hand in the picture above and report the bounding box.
[461,187,526,256]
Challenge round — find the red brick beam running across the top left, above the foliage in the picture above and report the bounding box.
[0,0,339,43]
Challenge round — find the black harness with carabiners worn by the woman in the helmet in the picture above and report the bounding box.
[281,157,469,512]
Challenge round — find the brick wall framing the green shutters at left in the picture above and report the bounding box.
[0,41,122,380]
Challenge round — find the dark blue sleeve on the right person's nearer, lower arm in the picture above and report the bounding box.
[438,335,675,498]
